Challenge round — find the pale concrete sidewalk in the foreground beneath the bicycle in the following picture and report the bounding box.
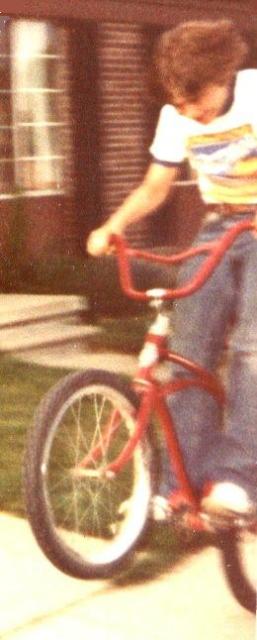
[0,514,255,640]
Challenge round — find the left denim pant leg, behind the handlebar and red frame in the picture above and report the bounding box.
[161,223,235,495]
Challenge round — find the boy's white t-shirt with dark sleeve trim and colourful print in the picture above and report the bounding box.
[150,69,257,204]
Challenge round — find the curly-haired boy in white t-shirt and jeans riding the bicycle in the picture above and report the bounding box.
[88,20,257,515]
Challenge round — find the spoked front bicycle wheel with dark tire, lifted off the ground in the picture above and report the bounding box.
[24,370,151,578]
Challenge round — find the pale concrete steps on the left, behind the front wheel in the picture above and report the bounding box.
[0,294,136,375]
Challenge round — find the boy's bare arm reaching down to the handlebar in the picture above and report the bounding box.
[87,162,178,256]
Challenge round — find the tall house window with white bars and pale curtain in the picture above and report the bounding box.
[0,18,71,197]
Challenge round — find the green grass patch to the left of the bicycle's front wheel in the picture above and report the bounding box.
[0,357,70,515]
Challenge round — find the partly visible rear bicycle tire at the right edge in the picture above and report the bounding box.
[218,530,257,614]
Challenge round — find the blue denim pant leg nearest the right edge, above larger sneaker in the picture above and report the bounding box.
[201,228,257,502]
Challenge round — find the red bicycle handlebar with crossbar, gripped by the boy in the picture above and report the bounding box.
[111,220,254,301]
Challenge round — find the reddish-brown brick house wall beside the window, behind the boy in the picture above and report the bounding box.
[0,0,254,290]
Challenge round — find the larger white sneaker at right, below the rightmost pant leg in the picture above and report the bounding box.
[201,482,253,516]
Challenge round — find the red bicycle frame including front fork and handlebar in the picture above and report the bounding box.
[80,220,254,528]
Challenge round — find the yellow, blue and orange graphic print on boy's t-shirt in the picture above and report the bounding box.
[188,124,257,204]
